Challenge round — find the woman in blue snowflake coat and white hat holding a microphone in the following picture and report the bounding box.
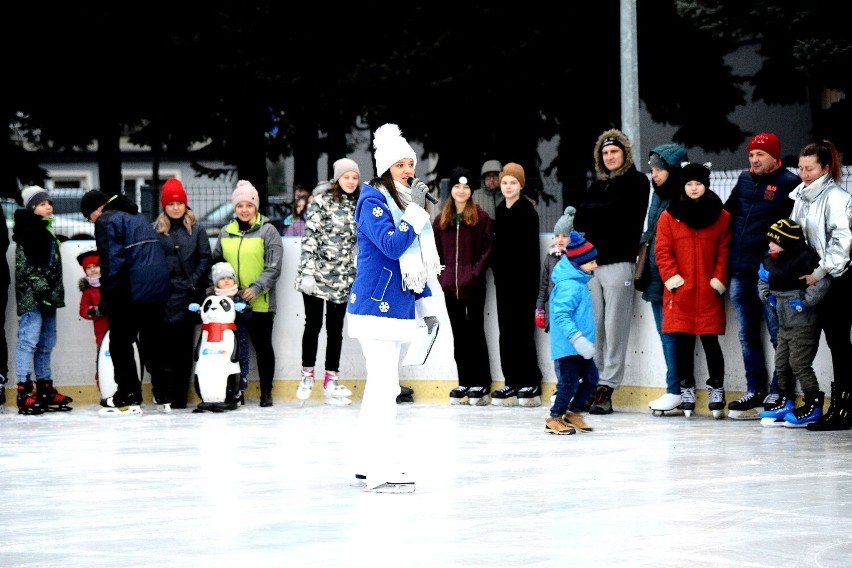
[348,124,441,493]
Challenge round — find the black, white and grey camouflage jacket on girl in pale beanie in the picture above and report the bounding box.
[295,192,357,304]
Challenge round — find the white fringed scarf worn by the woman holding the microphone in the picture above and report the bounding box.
[380,180,444,294]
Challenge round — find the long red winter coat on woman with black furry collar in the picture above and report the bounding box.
[656,199,731,335]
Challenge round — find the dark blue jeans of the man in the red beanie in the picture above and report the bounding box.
[730,276,778,393]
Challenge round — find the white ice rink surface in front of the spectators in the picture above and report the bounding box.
[0,395,852,568]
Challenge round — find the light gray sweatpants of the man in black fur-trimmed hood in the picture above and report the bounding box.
[589,262,636,389]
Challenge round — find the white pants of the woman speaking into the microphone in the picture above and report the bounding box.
[354,338,408,482]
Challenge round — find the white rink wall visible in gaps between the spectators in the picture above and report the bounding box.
[6,233,832,391]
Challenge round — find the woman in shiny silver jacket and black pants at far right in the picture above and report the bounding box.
[790,140,852,431]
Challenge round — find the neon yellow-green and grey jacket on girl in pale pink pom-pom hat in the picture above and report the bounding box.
[213,214,284,312]
